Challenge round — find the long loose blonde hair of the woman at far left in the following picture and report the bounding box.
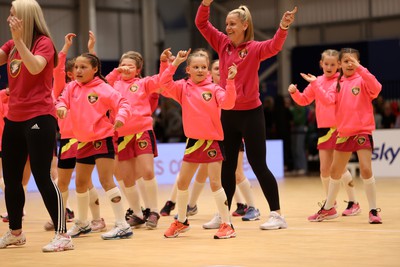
[11,0,58,67]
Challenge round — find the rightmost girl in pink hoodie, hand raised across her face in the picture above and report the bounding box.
[308,48,382,224]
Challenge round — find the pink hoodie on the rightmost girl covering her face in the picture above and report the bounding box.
[316,66,382,137]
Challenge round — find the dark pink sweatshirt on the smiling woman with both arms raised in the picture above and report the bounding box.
[195,5,287,110]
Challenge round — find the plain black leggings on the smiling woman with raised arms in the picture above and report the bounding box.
[221,106,280,211]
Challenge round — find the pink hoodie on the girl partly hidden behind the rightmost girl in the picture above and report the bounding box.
[290,73,339,128]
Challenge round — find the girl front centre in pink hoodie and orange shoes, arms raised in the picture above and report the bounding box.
[160,50,237,239]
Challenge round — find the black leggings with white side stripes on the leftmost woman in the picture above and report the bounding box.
[2,115,66,233]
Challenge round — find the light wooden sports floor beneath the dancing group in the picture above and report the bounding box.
[0,177,400,267]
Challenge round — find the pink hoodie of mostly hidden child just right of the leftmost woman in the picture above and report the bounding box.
[53,51,74,139]
